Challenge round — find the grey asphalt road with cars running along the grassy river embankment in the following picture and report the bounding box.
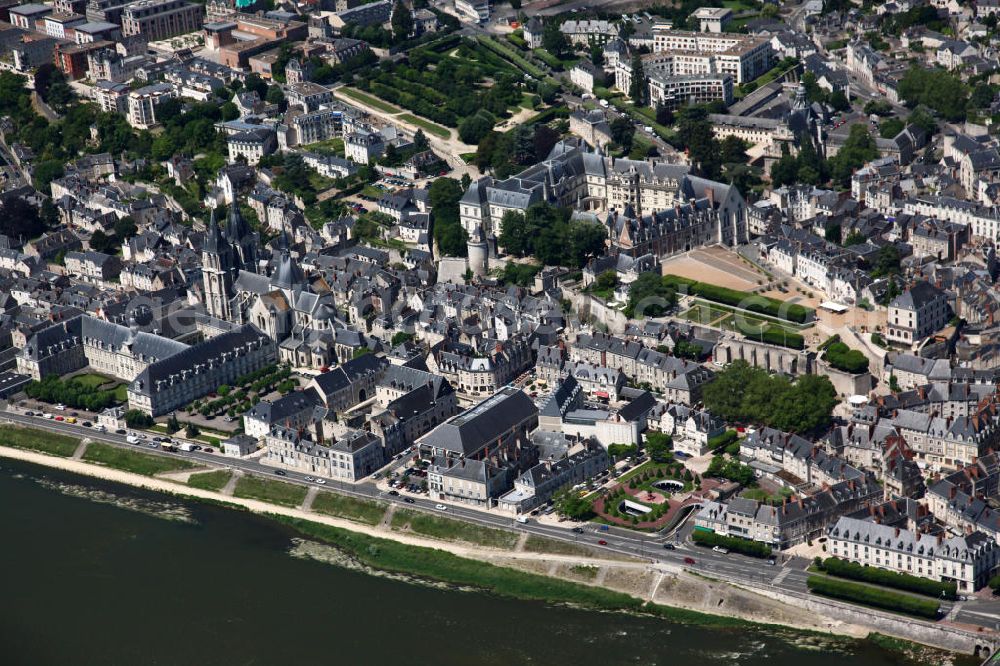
[3,405,1000,630]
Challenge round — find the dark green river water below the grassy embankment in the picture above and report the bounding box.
[0,459,940,666]
